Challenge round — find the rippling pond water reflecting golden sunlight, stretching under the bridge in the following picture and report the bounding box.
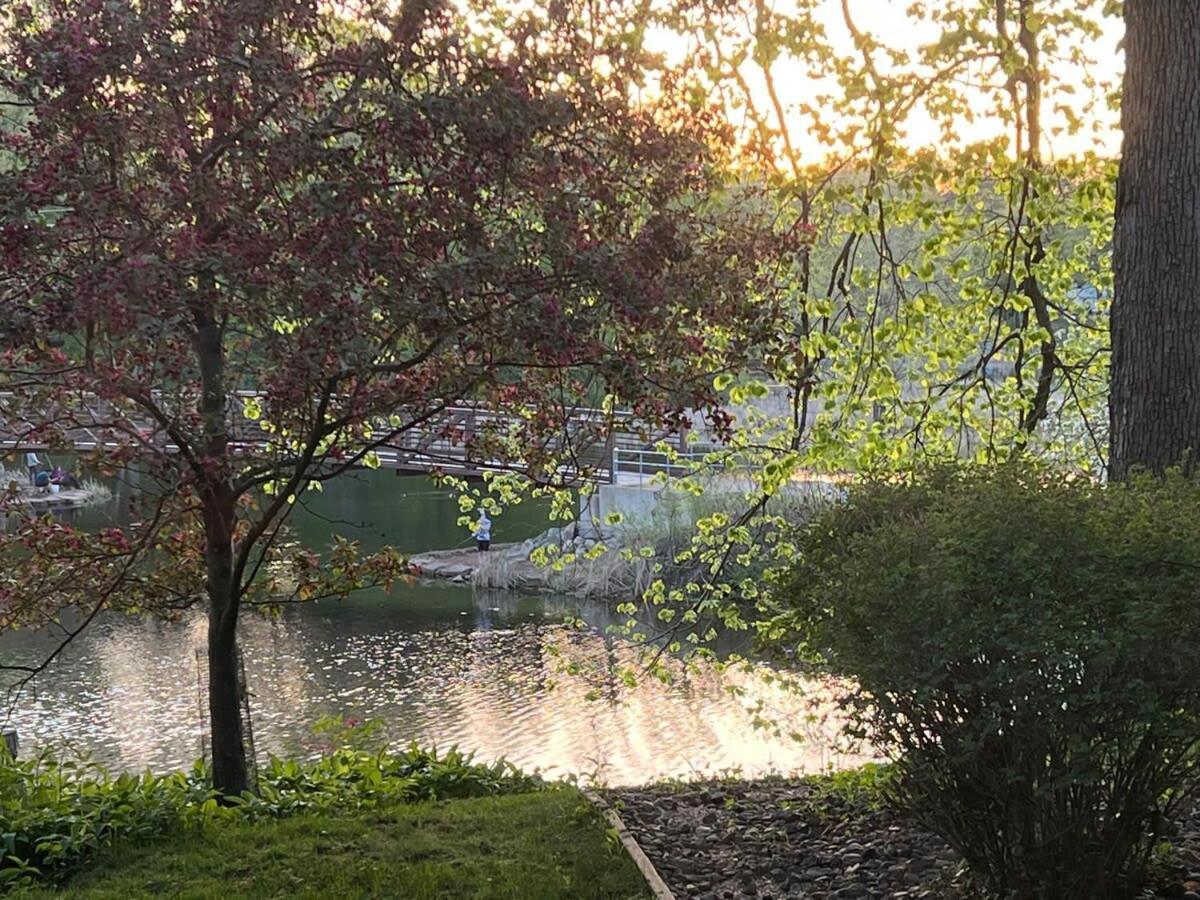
[0,472,846,784]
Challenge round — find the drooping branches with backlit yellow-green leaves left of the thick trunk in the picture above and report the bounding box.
[525,0,1116,653]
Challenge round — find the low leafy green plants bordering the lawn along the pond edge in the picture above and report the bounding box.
[0,745,544,892]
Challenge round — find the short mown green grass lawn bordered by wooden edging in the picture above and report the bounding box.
[17,788,649,900]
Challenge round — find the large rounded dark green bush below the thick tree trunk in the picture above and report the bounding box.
[775,466,1200,900]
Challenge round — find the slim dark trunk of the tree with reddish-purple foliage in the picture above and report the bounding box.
[196,314,250,797]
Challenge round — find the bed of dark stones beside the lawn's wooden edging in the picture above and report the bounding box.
[606,780,1200,900]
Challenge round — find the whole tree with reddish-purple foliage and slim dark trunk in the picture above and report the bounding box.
[0,0,776,793]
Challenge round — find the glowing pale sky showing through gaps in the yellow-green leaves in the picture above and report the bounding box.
[659,0,1123,163]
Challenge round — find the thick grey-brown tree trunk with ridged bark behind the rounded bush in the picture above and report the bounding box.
[1109,0,1200,479]
